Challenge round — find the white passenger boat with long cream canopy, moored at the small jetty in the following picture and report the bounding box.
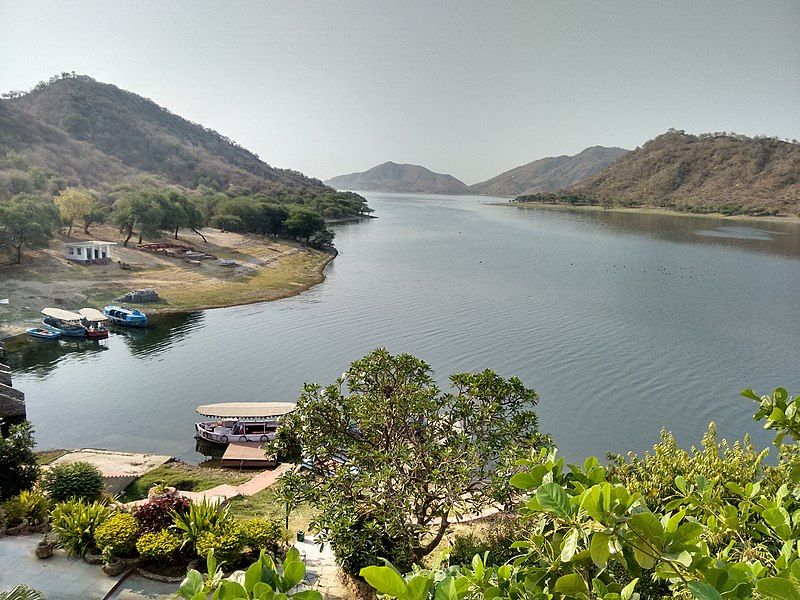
[194,402,296,445]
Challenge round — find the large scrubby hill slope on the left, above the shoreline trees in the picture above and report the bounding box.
[0,75,330,194]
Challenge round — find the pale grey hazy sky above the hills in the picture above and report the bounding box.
[0,0,800,183]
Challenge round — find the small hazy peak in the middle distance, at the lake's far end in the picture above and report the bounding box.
[325,162,470,194]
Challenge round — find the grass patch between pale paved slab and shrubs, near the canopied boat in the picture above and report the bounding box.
[120,462,253,502]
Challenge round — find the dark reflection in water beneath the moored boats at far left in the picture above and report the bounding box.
[6,336,109,378]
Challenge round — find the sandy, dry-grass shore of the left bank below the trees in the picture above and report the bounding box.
[0,225,336,339]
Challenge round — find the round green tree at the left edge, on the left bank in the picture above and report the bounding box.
[0,194,60,264]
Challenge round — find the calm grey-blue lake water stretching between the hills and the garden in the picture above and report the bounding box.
[6,194,800,460]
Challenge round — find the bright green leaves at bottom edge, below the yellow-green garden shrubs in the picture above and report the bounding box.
[178,548,322,600]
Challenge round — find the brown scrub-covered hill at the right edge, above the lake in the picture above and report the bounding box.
[527,130,800,215]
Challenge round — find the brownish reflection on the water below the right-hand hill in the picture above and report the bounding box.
[530,207,800,258]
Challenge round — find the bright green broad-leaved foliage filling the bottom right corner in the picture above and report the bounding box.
[361,388,800,600]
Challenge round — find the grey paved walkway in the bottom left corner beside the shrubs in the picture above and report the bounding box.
[0,535,179,600]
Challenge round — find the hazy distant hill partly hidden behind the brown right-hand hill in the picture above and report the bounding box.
[470,146,628,196]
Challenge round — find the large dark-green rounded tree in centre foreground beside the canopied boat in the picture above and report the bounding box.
[278,349,546,573]
